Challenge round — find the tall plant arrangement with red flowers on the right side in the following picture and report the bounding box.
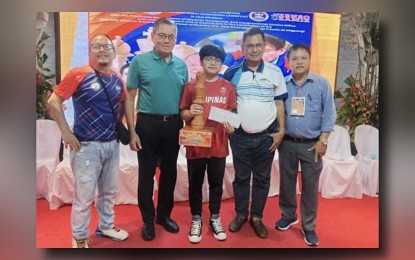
[334,12,379,140]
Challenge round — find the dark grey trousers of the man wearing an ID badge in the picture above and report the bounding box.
[278,139,323,231]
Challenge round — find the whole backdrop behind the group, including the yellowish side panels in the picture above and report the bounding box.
[58,12,341,125]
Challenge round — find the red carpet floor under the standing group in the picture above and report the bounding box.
[36,196,379,248]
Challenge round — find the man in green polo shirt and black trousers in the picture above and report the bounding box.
[125,18,188,241]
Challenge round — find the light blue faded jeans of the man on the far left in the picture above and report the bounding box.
[70,140,120,239]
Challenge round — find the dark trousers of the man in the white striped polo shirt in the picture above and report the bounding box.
[230,124,277,218]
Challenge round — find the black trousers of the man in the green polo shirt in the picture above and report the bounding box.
[136,114,183,223]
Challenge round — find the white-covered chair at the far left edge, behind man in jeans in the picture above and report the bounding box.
[36,119,61,200]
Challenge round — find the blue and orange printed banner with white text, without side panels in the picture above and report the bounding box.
[89,12,313,78]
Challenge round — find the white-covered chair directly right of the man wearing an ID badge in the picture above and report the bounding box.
[319,125,362,199]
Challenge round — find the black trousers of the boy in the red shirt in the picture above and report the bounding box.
[187,158,226,216]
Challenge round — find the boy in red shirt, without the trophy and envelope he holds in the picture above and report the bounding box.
[180,44,236,243]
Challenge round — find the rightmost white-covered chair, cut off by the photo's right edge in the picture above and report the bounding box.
[355,125,379,197]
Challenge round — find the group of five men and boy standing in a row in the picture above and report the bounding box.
[49,18,336,248]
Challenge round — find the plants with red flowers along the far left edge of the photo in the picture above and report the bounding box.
[36,32,55,119]
